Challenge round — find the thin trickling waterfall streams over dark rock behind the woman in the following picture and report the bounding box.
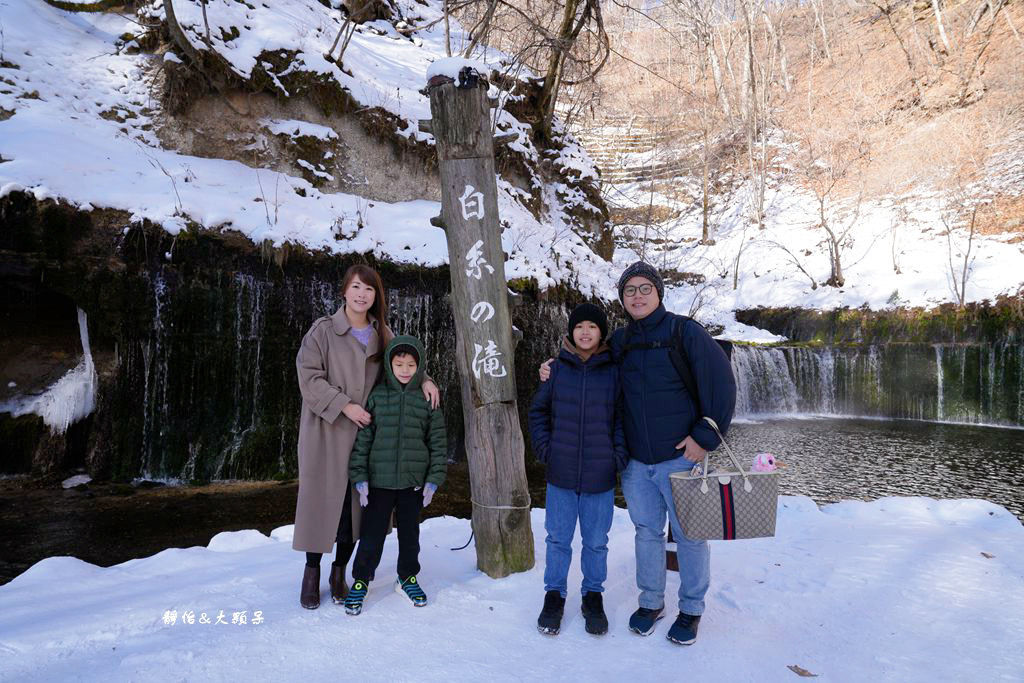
[115,268,565,481]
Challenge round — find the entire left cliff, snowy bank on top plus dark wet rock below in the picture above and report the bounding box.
[0,0,614,479]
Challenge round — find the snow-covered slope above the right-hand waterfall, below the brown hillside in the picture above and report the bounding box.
[610,172,1024,341]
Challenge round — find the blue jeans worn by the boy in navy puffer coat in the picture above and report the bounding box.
[544,483,615,598]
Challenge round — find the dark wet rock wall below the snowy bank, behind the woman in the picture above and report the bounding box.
[0,193,566,481]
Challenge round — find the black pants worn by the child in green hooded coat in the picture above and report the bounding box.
[352,488,423,581]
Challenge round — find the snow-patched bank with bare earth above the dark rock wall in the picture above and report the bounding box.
[0,0,613,297]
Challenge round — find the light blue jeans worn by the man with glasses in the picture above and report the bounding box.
[623,456,711,615]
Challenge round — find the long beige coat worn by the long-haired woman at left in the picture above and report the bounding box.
[292,306,391,553]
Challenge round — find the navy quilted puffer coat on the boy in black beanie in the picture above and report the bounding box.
[529,340,628,494]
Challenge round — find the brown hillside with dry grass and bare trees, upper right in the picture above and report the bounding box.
[566,0,1024,233]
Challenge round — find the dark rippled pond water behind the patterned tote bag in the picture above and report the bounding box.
[729,418,1024,521]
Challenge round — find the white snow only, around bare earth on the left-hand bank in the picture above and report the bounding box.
[0,0,614,297]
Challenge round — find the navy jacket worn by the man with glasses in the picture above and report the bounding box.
[608,305,736,464]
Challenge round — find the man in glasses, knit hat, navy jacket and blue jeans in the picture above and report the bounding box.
[609,261,736,645]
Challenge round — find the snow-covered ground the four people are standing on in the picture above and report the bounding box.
[0,497,1024,683]
